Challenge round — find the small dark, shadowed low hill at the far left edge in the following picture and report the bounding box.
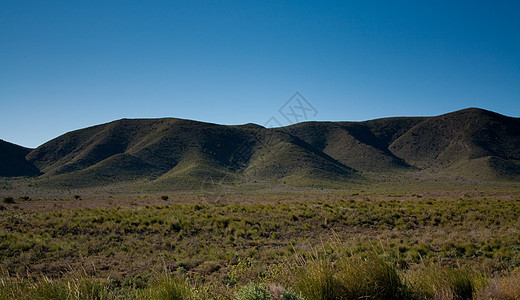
[0,140,40,177]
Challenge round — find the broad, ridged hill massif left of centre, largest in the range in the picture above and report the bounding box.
[23,118,354,187]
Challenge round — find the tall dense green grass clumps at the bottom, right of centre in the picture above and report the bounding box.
[288,250,476,299]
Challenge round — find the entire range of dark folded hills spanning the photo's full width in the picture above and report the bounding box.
[0,108,520,188]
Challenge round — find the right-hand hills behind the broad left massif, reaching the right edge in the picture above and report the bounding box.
[287,108,520,180]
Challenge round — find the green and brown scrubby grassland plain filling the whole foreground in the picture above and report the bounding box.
[0,194,520,299]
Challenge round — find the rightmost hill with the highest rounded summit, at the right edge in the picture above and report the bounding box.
[389,108,520,179]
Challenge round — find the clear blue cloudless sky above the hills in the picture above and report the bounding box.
[0,0,520,147]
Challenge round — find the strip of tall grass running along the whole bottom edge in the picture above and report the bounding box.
[0,249,520,300]
